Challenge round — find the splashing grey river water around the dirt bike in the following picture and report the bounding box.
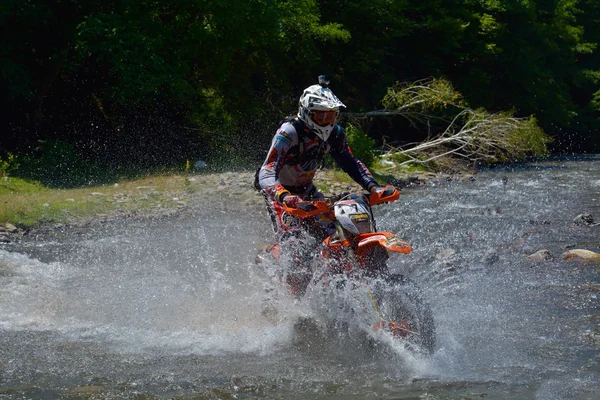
[0,156,600,400]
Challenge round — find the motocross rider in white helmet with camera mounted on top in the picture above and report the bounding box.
[257,75,398,295]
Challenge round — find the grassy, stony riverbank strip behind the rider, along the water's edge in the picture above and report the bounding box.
[0,169,474,243]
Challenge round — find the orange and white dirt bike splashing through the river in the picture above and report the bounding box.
[257,186,435,353]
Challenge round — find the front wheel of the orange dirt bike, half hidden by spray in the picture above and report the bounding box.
[372,274,435,354]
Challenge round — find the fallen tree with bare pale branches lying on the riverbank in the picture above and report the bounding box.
[354,79,551,166]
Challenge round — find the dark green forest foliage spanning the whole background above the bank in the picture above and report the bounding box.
[0,0,600,178]
